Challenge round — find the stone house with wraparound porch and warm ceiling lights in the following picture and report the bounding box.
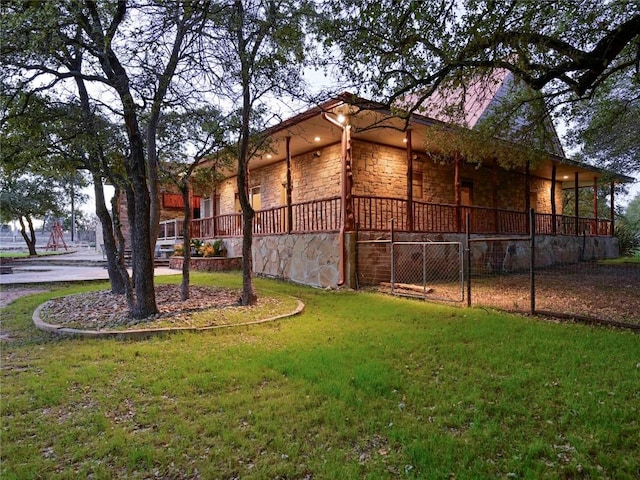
[159,75,629,287]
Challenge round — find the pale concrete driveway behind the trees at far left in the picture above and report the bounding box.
[0,249,180,285]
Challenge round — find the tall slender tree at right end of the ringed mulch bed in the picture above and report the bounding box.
[204,0,313,305]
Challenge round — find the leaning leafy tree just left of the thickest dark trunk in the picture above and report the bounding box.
[2,85,130,294]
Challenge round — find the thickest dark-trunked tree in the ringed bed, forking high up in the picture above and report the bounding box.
[2,0,212,318]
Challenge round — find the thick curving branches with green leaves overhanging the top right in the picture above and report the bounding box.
[323,0,640,109]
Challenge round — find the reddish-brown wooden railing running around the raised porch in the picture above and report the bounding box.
[160,195,613,240]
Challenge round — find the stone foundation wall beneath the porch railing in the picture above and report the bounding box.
[202,232,619,288]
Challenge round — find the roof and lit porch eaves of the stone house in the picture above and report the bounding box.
[239,89,633,187]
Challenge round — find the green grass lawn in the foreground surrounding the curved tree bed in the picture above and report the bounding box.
[0,273,640,480]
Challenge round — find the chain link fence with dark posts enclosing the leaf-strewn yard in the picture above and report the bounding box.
[357,214,640,330]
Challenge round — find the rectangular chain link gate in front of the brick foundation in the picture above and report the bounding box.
[390,242,464,302]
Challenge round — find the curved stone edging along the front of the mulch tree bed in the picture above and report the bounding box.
[32,299,305,340]
